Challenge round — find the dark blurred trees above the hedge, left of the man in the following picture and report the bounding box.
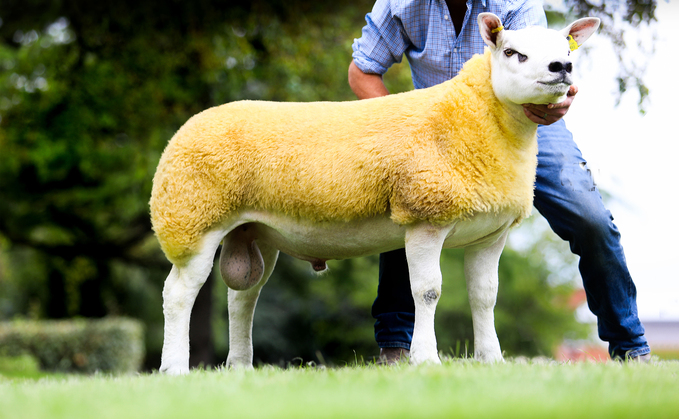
[0,0,396,368]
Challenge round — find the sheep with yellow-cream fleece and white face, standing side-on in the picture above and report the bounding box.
[150,13,599,374]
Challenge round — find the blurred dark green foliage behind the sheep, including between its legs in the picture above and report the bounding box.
[0,0,652,367]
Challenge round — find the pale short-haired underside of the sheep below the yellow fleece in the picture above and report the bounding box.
[227,212,516,261]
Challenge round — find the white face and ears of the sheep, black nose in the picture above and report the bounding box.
[478,13,600,105]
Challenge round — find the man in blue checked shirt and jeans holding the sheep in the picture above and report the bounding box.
[349,0,651,363]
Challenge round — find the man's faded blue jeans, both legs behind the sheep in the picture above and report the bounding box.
[372,120,651,358]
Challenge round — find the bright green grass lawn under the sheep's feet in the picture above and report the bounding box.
[0,360,679,419]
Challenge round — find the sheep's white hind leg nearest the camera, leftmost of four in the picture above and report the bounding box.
[160,232,223,375]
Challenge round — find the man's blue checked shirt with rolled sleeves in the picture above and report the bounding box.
[352,0,547,89]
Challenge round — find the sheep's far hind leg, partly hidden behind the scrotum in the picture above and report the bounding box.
[222,243,278,368]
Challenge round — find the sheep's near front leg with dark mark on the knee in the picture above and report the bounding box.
[406,223,450,364]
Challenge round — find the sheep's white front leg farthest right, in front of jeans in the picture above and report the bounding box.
[464,232,507,362]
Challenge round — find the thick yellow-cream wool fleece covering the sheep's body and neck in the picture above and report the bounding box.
[150,51,537,263]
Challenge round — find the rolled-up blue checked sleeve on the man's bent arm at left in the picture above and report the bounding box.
[351,0,409,74]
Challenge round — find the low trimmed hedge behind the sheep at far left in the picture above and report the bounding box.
[0,318,145,373]
